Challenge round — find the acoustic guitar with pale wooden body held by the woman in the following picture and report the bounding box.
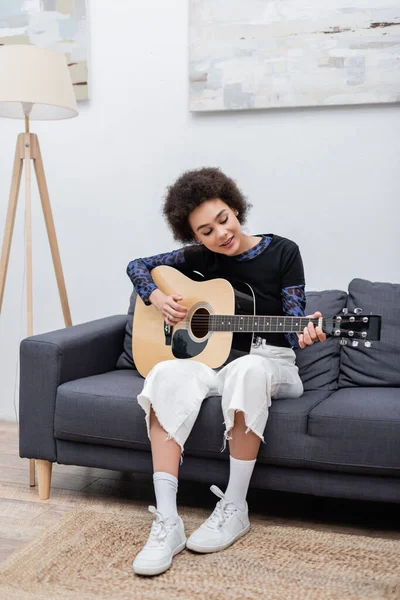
[132,266,381,377]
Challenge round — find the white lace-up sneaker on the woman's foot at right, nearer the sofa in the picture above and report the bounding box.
[186,485,250,552]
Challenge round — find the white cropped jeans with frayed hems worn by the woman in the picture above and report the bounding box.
[137,340,303,452]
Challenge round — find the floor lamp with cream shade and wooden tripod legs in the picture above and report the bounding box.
[0,44,78,486]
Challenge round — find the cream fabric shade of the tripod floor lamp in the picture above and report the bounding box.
[0,44,78,121]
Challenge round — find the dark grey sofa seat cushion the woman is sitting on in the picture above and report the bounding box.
[54,370,329,466]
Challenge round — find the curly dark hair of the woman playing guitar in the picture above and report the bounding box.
[162,167,251,243]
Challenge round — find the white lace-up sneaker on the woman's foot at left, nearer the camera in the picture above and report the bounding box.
[132,506,186,575]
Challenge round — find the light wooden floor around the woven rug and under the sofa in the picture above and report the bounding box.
[0,421,400,561]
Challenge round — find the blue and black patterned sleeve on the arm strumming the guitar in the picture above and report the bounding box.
[126,248,185,306]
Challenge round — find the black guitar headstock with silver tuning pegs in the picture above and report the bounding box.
[323,308,382,348]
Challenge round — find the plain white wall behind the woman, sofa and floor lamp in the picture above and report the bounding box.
[0,0,400,420]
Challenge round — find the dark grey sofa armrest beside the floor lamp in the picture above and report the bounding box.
[19,315,128,462]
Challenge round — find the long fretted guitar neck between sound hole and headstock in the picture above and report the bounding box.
[208,315,320,333]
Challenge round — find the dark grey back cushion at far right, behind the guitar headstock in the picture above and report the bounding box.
[339,279,400,387]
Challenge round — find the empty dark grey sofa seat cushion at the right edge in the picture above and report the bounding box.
[305,388,400,476]
